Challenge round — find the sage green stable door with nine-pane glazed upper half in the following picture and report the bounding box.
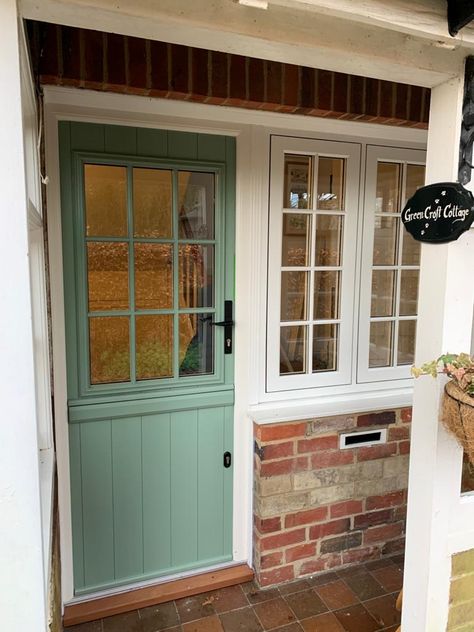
[59,122,235,594]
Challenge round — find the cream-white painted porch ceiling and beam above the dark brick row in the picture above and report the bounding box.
[19,0,474,87]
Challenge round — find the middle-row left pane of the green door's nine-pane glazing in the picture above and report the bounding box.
[87,242,128,312]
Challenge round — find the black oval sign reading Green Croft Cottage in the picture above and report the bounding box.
[401,182,474,244]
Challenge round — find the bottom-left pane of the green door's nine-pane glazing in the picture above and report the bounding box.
[89,316,130,384]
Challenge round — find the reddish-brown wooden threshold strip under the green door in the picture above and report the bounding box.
[63,564,253,627]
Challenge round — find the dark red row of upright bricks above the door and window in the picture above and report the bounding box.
[28,22,430,128]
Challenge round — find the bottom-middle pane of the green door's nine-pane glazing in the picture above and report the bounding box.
[135,314,173,380]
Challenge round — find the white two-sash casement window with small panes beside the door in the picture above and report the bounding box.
[267,136,424,392]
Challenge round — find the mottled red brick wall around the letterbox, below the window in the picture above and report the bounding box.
[254,408,411,586]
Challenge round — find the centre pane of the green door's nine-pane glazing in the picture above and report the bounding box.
[135,243,173,309]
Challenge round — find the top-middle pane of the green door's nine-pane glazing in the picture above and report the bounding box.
[133,168,173,239]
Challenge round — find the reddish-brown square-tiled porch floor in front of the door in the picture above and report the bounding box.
[66,556,403,632]
